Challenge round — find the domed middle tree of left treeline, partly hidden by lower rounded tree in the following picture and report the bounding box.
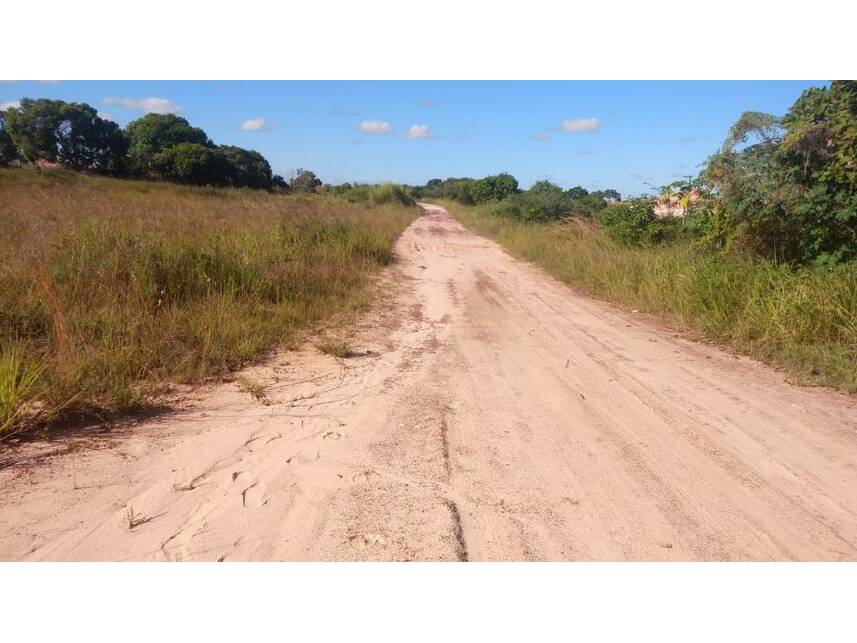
[125,114,214,177]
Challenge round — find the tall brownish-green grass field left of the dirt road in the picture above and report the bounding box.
[0,170,418,438]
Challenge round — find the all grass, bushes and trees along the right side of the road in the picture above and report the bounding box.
[434,81,857,391]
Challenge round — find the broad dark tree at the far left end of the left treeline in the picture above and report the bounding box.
[4,98,127,171]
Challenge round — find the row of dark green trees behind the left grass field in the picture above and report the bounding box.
[0,98,322,191]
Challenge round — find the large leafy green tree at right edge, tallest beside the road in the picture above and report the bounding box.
[703,81,857,266]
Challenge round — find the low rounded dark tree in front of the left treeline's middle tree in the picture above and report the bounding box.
[150,143,233,186]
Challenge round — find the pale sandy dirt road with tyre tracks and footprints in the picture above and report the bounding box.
[0,207,857,561]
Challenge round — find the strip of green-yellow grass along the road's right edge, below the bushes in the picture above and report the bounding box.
[444,202,857,391]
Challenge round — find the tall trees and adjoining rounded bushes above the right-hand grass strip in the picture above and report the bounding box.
[599,81,857,268]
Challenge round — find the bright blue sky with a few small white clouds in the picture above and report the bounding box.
[0,81,827,195]
